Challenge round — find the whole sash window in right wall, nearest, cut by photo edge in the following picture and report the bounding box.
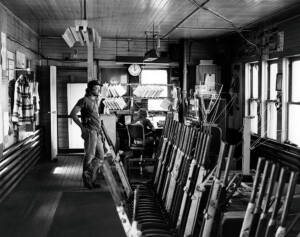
[288,58,300,146]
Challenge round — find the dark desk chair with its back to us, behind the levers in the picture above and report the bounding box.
[126,123,145,175]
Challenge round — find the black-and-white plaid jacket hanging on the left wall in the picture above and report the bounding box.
[12,75,34,125]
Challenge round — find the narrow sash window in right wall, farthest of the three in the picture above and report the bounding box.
[246,63,260,133]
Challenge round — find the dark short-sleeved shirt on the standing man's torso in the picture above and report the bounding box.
[76,96,101,131]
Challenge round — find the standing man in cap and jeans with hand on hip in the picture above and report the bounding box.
[70,80,104,189]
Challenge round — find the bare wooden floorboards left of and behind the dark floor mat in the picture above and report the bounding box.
[0,155,121,237]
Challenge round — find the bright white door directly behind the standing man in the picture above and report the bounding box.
[67,83,86,149]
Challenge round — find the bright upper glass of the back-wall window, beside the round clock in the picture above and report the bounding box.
[141,69,168,97]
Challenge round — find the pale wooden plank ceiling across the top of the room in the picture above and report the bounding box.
[0,0,299,39]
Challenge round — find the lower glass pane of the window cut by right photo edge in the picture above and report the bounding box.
[288,104,300,146]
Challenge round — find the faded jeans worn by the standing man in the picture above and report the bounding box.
[82,129,104,182]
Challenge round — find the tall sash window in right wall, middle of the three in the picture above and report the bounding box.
[266,61,278,140]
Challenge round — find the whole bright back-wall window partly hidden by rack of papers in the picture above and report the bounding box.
[141,69,168,111]
